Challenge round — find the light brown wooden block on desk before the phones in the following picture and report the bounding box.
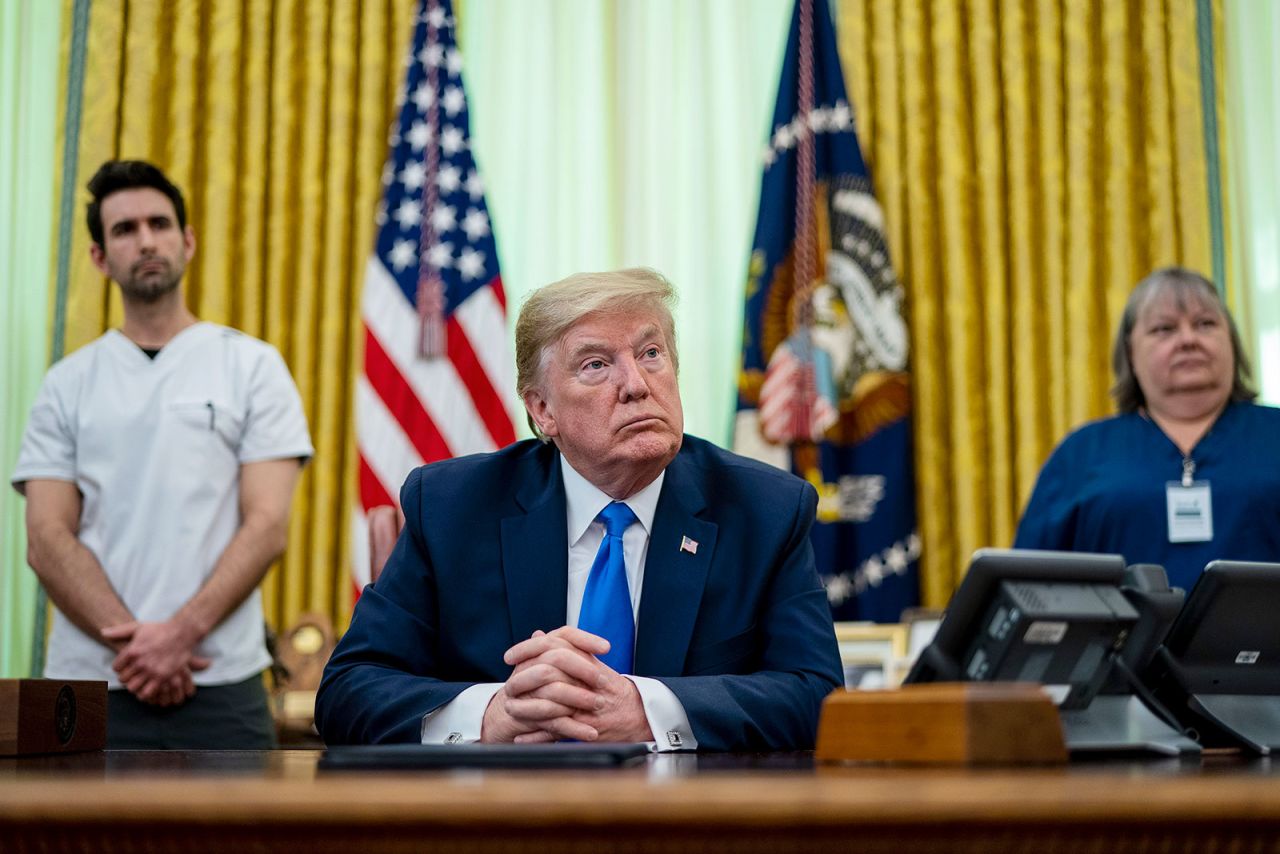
[817,682,1066,764]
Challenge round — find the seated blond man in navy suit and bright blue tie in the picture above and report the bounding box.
[316,270,842,750]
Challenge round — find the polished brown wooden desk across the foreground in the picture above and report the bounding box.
[0,750,1280,854]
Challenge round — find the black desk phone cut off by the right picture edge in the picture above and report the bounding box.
[1144,561,1280,755]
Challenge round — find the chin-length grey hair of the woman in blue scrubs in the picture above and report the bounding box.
[1111,266,1258,412]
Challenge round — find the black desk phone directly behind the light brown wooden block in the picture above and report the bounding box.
[906,549,1198,755]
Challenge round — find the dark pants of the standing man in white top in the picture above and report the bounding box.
[106,673,275,750]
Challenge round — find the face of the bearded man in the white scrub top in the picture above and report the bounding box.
[90,187,196,302]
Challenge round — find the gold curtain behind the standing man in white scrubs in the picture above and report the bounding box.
[50,0,413,627]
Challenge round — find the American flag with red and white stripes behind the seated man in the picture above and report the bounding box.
[352,0,516,594]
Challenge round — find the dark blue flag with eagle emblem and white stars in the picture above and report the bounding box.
[735,0,920,622]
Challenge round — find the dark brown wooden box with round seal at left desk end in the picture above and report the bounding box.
[0,679,106,757]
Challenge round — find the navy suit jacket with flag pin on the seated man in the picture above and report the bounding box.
[316,437,842,750]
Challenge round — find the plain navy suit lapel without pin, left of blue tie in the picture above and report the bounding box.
[500,449,568,643]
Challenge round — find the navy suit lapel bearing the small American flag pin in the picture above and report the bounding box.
[635,455,719,676]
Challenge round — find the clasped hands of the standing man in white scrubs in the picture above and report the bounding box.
[102,620,210,705]
